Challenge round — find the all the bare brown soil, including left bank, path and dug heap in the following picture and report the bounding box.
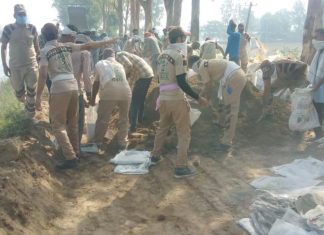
[0,80,323,235]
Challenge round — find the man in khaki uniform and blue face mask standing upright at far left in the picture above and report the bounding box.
[1,4,39,118]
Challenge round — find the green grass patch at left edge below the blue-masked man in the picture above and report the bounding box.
[0,80,31,138]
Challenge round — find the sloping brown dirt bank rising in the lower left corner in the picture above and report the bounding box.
[0,124,62,234]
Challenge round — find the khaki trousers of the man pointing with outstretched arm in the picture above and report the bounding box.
[49,91,79,160]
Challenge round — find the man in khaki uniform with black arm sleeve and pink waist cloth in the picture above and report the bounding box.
[151,27,208,178]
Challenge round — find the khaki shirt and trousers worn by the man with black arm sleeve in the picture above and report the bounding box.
[152,44,191,167]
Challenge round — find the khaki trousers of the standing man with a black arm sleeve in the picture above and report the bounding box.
[152,100,191,167]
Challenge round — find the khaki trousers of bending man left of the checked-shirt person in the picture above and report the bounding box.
[95,99,130,145]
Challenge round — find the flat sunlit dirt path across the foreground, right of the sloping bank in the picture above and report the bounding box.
[39,132,316,235]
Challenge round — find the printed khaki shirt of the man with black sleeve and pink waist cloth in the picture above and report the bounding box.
[158,44,187,100]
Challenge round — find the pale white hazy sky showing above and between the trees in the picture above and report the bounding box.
[0,0,307,30]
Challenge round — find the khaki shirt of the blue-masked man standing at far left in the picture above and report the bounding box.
[1,24,38,68]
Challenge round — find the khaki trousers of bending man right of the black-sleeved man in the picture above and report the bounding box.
[221,70,247,145]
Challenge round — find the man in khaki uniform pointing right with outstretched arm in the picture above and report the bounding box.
[36,23,115,170]
